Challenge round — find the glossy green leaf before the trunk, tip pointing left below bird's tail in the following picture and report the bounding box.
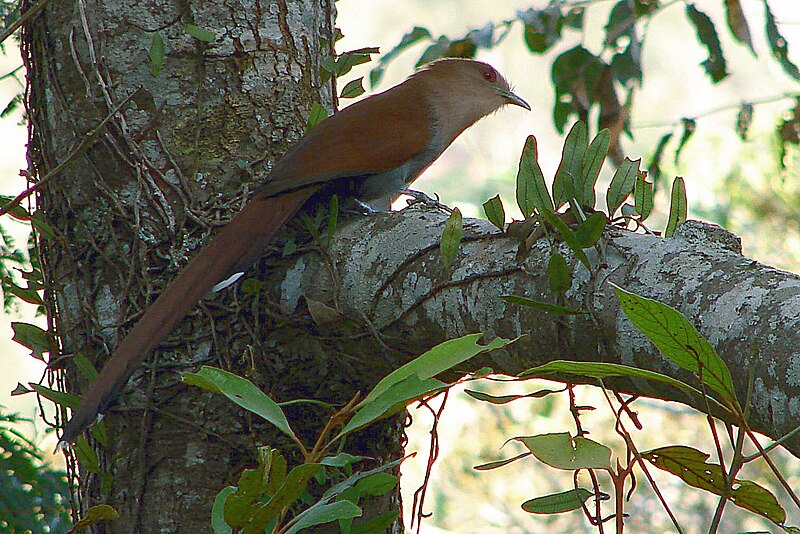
[182,365,300,443]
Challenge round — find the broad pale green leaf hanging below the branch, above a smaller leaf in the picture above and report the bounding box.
[513,432,611,471]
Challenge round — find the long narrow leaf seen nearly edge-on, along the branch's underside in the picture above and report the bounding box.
[517,360,728,411]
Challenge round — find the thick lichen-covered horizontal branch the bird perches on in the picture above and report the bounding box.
[276,209,800,456]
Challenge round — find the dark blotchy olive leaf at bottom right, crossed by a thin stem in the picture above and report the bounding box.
[642,445,786,525]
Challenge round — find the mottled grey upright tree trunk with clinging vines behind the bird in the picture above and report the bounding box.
[18,0,401,532]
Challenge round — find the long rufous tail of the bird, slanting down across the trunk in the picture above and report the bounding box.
[57,185,319,450]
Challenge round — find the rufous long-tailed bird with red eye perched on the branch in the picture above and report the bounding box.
[58,59,531,449]
